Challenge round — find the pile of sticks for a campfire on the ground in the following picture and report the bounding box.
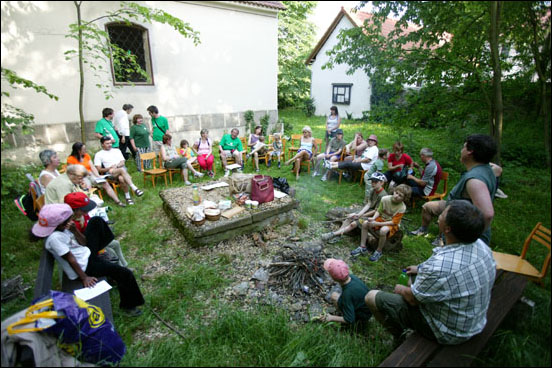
[268,245,325,295]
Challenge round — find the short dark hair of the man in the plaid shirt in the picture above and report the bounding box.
[445,200,485,243]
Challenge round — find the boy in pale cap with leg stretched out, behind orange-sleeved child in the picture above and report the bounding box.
[321,172,387,241]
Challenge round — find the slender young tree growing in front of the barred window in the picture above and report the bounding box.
[65,1,200,142]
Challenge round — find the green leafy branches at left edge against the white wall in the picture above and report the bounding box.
[2,68,59,149]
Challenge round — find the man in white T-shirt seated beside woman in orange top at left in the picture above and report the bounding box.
[94,137,144,207]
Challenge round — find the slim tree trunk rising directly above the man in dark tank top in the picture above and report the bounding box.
[489,1,504,165]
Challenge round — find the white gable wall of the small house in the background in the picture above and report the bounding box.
[311,17,372,118]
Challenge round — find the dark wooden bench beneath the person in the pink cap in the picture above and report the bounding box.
[34,248,113,323]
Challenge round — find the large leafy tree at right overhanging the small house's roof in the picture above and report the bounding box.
[330,1,540,160]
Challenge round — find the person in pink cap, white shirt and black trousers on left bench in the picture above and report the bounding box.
[31,203,145,316]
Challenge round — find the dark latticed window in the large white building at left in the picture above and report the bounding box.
[106,23,153,85]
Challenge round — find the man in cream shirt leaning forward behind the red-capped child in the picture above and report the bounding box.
[44,163,89,204]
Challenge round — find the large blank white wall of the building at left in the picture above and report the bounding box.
[1,1,278,124]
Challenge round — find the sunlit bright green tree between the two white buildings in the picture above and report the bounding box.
[278,1,317,108]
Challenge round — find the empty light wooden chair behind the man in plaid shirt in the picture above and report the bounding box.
[493,222,550,286]
